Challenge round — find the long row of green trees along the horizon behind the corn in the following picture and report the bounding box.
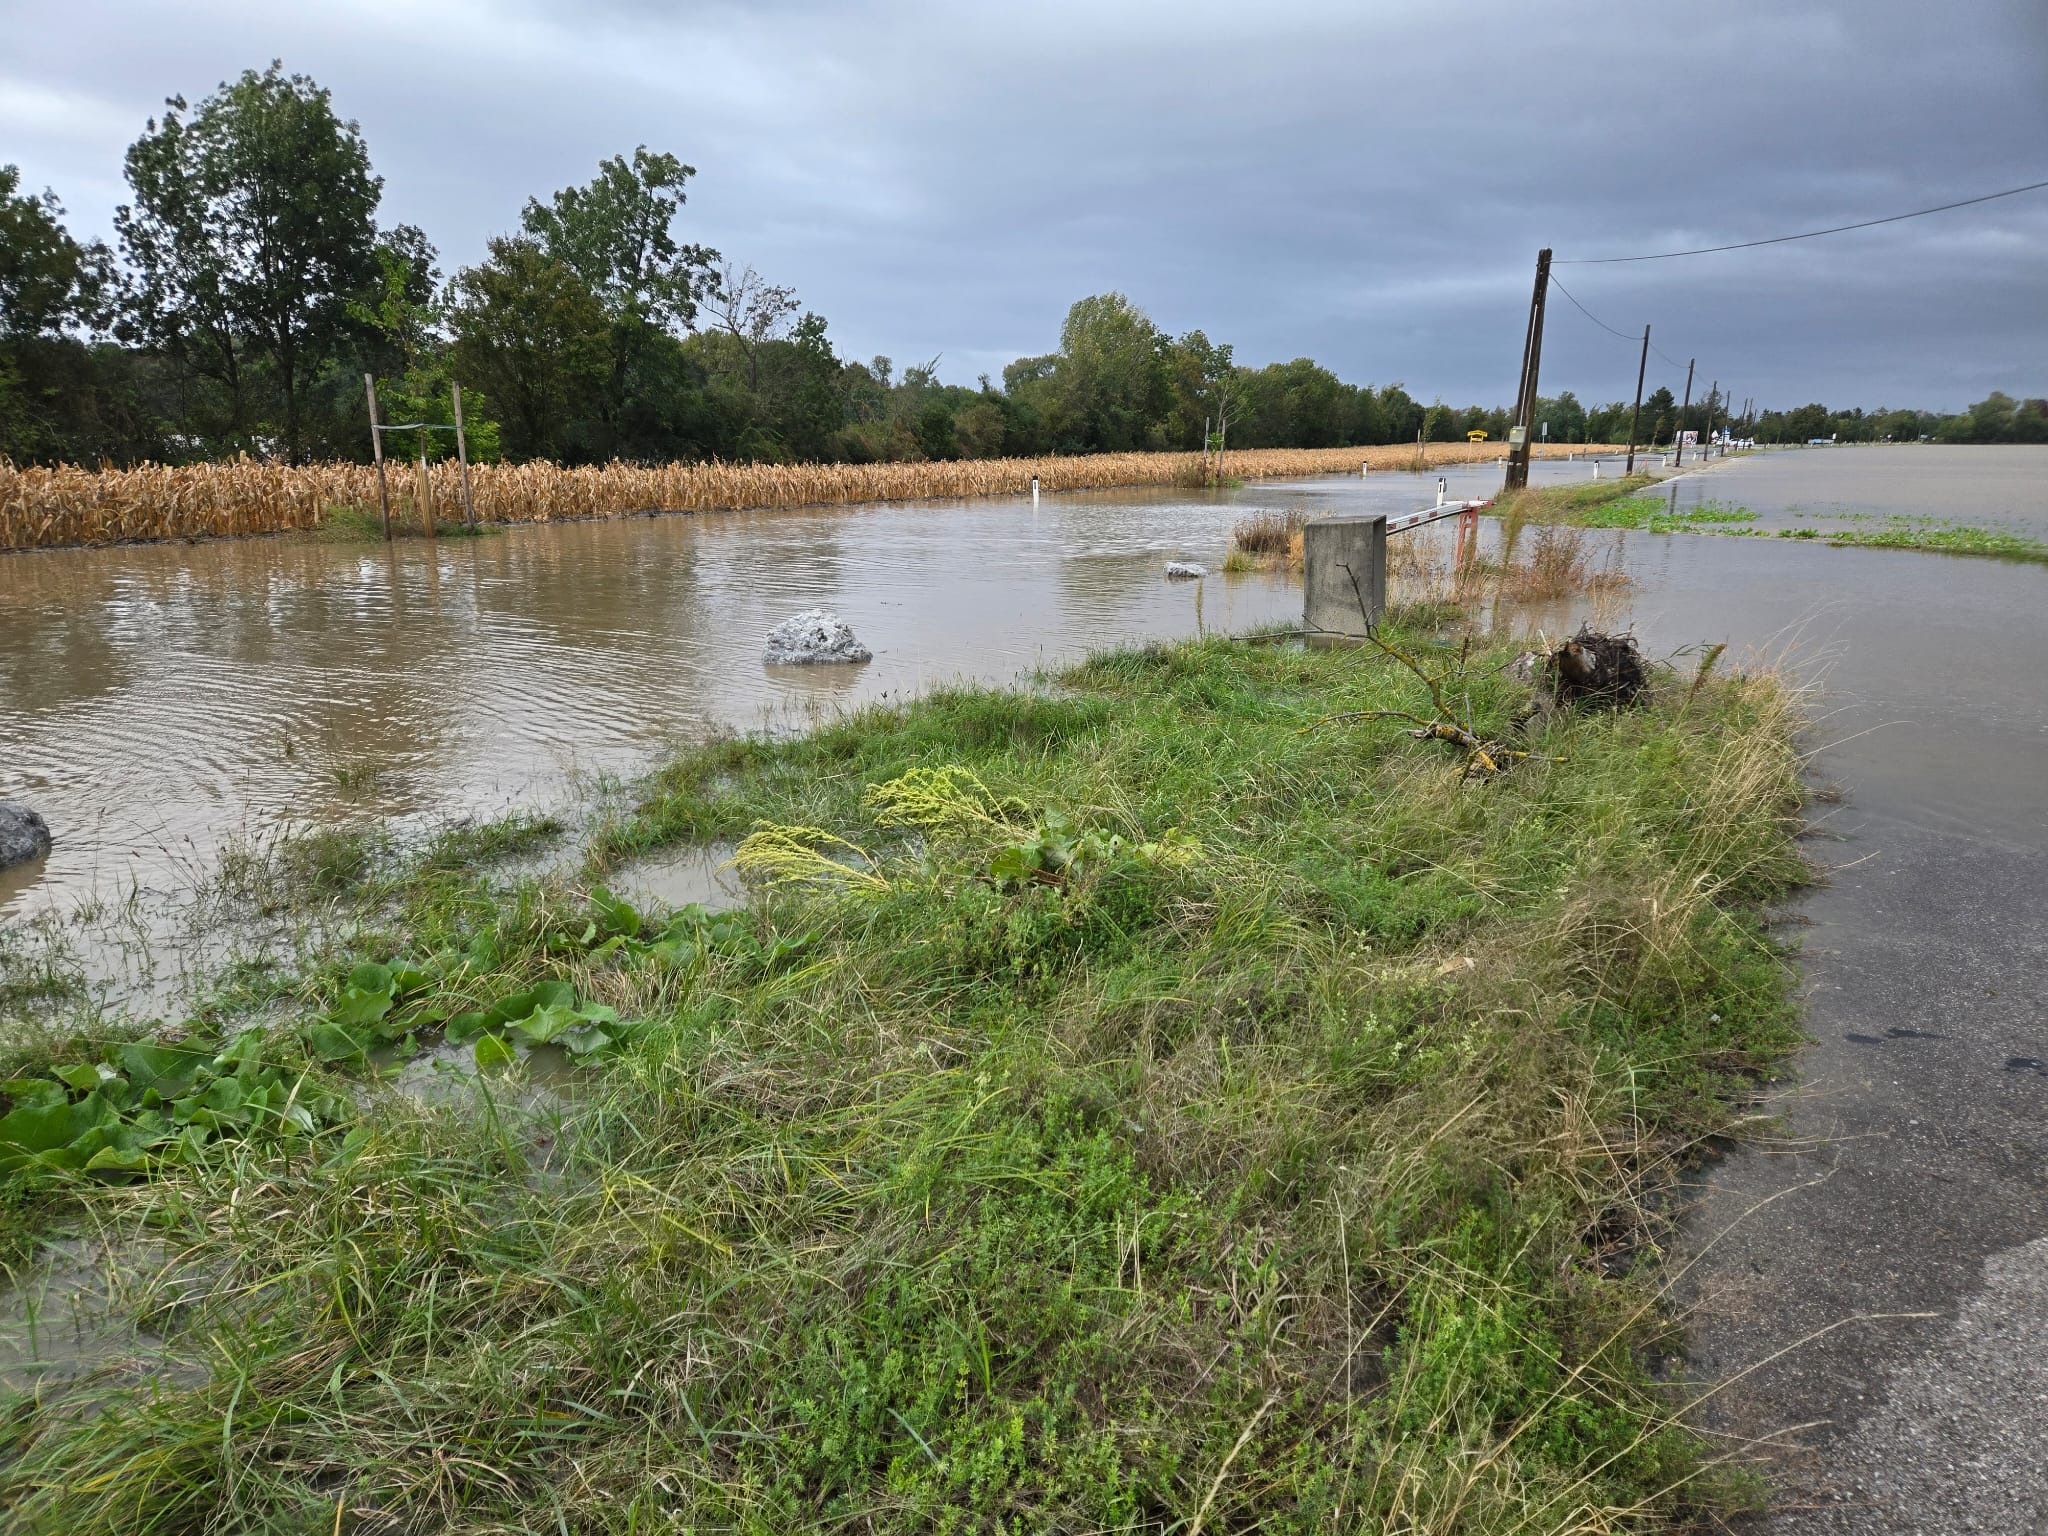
[0,63,2048,463]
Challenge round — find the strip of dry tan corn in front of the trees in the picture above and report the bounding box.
[0,442,1630,549]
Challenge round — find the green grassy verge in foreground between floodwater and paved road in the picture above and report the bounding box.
[0,637,1804,1532]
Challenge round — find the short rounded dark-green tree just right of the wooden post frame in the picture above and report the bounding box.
[449,236,612,459]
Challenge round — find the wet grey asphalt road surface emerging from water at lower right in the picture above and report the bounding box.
[1681,823,2048,1536]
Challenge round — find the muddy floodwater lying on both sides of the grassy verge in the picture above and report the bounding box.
[0,446,2048,915]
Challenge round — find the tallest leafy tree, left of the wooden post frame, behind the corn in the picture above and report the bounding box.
[115,63,383,461]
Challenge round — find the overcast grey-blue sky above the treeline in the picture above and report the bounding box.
[0,0,2048,408]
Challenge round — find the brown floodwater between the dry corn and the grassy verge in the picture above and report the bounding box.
[0,465,1523,911]
